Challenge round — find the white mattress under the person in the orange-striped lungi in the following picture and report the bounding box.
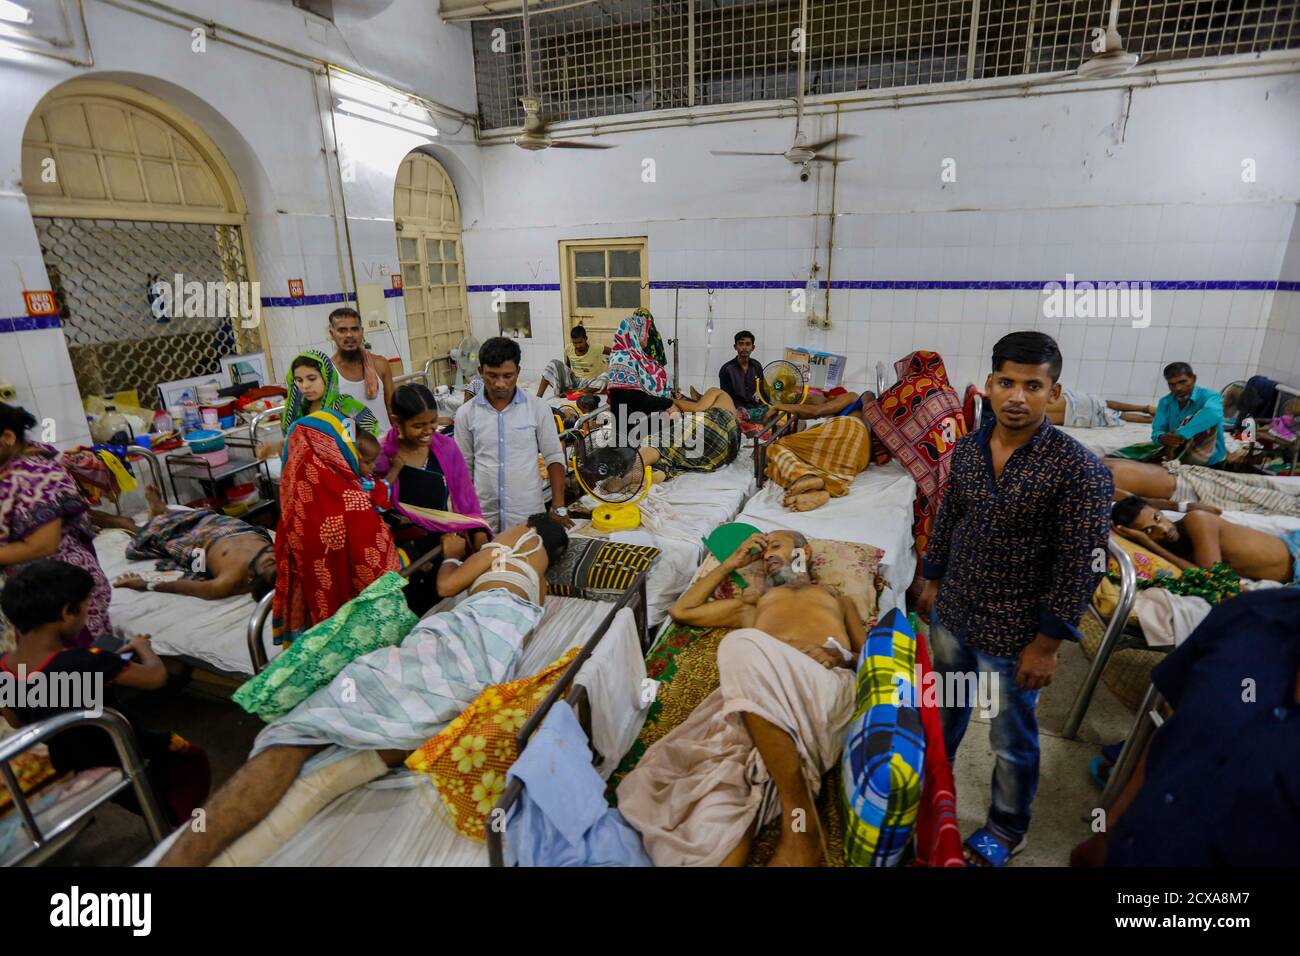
[736,462,917,614]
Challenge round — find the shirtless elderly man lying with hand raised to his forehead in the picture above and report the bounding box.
[619,531,867,866]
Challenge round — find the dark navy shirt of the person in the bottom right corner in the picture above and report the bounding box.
[1106,588,1300,866]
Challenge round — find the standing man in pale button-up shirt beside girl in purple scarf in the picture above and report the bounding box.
[455,336,573,532]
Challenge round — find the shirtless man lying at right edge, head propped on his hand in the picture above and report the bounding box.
[1110,496,1300,585]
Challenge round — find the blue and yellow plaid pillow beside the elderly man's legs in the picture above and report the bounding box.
[840,607,926,866]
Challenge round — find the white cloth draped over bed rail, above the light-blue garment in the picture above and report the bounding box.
[573,607,654,779]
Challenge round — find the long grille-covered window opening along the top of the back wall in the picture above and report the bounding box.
[473,0,1300,129]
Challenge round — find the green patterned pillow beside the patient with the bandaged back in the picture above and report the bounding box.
[231,571,419,723]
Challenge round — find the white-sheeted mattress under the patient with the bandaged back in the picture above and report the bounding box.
[142,597,614,866]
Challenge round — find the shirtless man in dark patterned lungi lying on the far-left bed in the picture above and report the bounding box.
[92,486,276,601]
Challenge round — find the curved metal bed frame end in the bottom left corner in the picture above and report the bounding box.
[0,708,169,865]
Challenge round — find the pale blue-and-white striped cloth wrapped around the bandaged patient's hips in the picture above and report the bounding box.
[252,588,542,773]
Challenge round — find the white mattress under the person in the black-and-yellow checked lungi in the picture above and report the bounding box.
[569,446,754,627]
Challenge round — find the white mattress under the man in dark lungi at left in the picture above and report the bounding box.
[95,529,277,676]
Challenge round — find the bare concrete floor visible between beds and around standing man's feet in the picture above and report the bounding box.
[27,629,1134,866]
